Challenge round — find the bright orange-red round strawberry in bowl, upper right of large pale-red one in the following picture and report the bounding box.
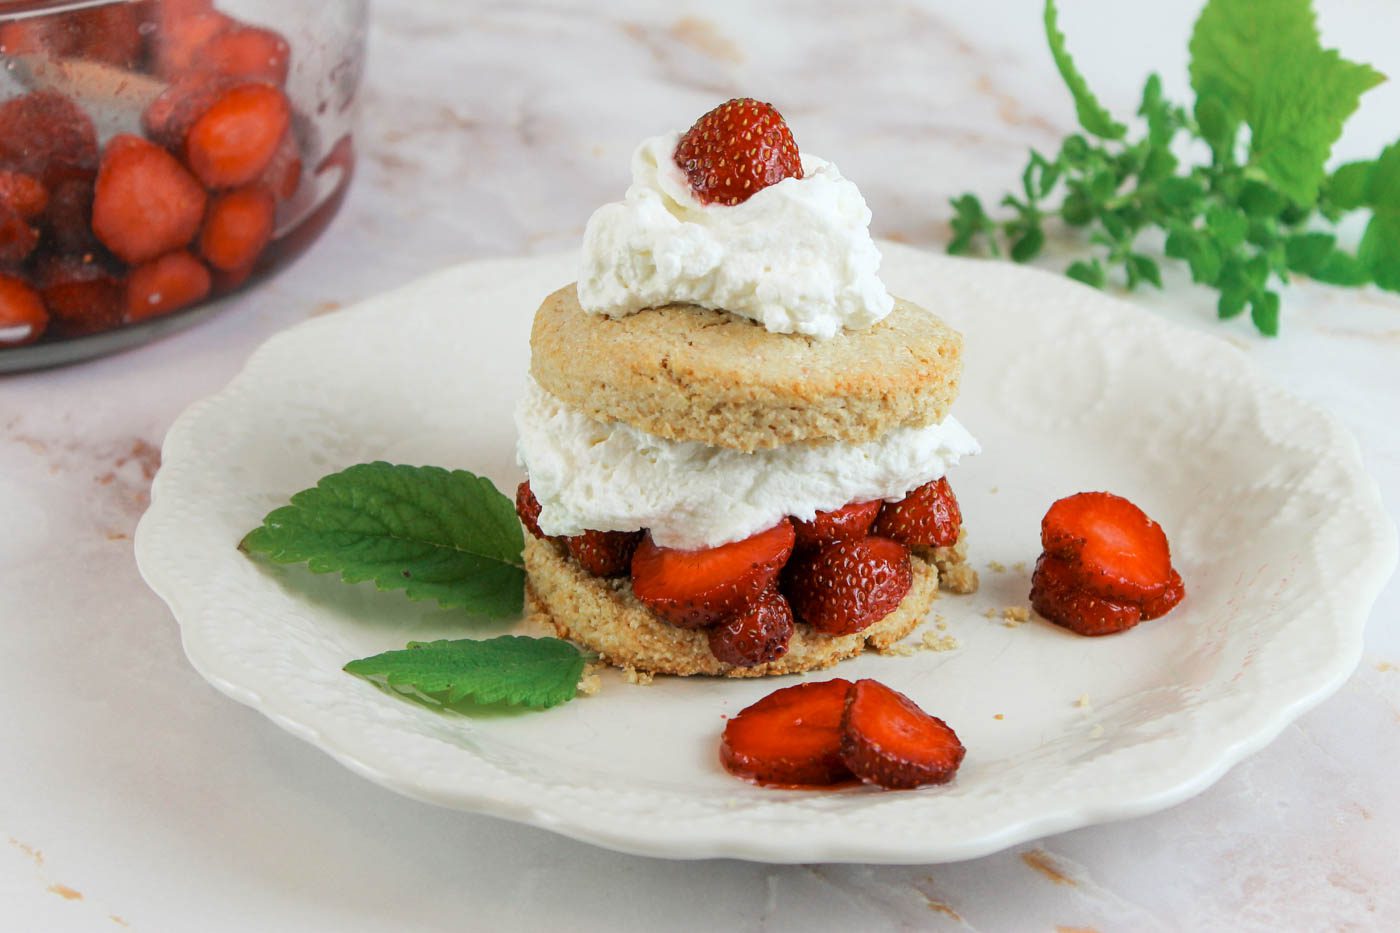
[185,83,291,188]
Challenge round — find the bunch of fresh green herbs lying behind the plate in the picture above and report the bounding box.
[948,0,1400,335]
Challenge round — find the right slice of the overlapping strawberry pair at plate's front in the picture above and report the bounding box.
[841,681,966,790]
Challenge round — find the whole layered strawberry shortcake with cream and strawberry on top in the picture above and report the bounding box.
[515,99,979,677]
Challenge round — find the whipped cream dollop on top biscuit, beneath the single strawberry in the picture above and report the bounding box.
[578,133,893,339]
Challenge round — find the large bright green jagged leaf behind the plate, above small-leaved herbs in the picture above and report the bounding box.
[1190,0,1385,203]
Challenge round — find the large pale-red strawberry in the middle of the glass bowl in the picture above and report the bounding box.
[92,134,207,265]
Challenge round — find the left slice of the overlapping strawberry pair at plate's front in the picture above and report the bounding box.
[720,678,851,787]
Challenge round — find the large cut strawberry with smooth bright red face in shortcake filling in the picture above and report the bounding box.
[631,518,795,629]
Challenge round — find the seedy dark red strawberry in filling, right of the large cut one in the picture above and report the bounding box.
[783,535,913,635]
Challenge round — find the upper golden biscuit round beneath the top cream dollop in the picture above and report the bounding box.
[531,284,962,451]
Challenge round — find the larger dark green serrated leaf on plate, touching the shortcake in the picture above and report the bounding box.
[239,462,525,616]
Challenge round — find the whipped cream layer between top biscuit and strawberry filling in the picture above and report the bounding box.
[515,380,980,548]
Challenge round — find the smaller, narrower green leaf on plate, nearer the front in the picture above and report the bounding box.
[344,635,587,709]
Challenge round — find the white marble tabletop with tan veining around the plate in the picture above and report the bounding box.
[0,0,1400,933]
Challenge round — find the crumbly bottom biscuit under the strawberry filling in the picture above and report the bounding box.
[525,534,974,677]
